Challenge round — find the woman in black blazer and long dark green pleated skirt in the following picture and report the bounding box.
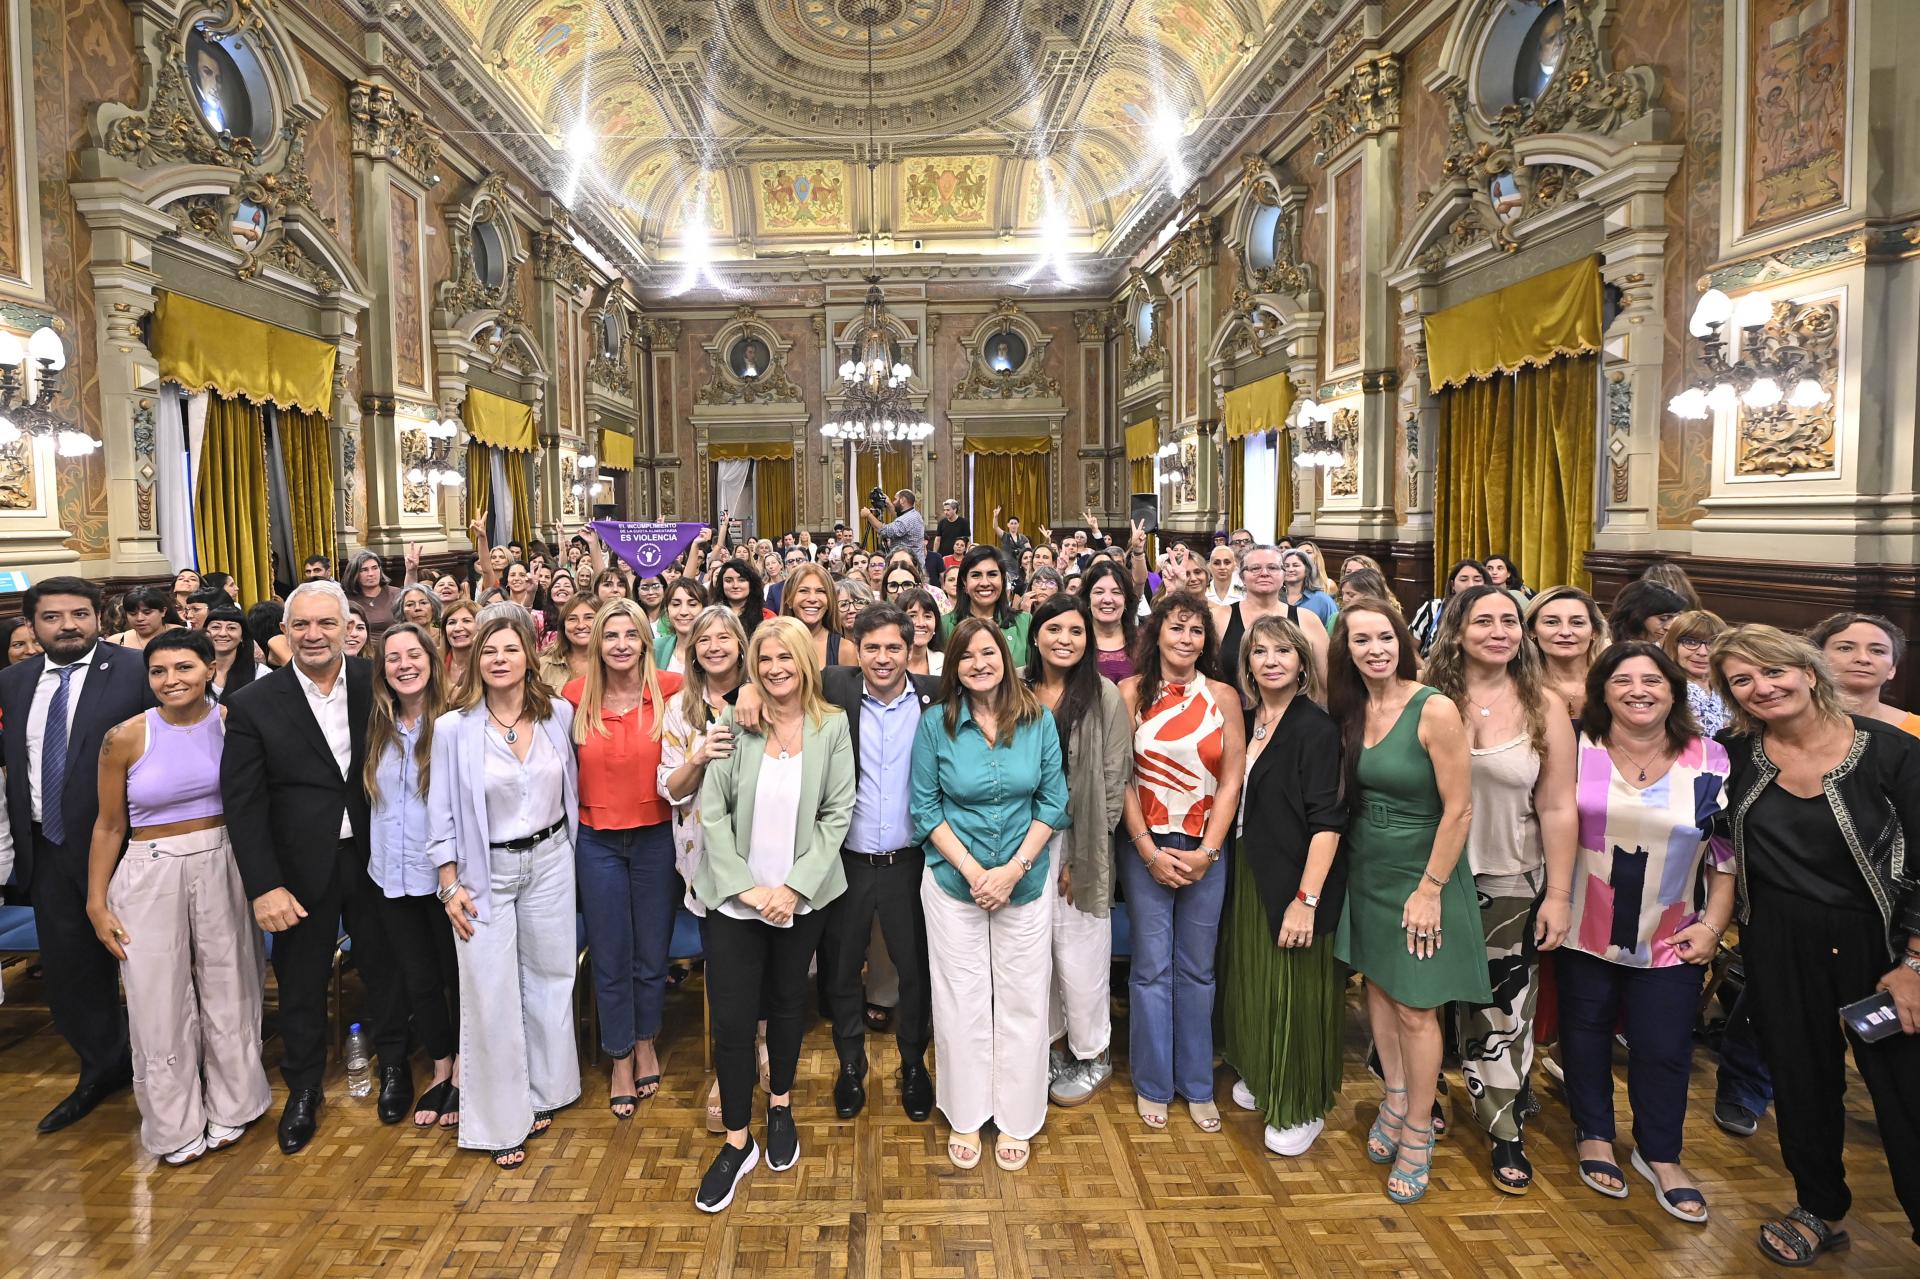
[1223,616,1346,1156]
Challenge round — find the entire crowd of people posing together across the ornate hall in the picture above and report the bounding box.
[0,511,1920,1266]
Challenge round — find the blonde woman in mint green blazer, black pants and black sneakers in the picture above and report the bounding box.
[693,616,854,1212]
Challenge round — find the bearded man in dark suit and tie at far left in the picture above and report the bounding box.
[0,578,154,1133]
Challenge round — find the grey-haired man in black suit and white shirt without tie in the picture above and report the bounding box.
[221,582,385,1154]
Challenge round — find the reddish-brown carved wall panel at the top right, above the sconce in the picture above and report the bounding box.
[1745,0,1851,230]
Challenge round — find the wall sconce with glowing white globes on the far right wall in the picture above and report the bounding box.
[1667,288,1834,421]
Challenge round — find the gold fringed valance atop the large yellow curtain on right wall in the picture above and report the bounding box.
[1427,257,1601,390]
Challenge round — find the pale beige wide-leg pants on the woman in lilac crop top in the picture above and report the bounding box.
[108,826,273,1154]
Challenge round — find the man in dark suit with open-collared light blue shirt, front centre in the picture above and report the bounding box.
[820,603,939,1122]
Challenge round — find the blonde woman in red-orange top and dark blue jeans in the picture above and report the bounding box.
[563,599,680,1120]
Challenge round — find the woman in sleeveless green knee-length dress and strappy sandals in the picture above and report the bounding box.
[1327,599,1494,1204]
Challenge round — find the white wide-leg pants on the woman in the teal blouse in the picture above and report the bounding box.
[920,876,1054,1141]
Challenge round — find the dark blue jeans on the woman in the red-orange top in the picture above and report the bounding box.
[578,822,682,1056]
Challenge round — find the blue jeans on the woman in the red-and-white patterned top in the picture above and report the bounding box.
[1119,835,1227,1104]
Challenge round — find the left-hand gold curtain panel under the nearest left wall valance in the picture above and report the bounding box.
[194,396,273,605]
